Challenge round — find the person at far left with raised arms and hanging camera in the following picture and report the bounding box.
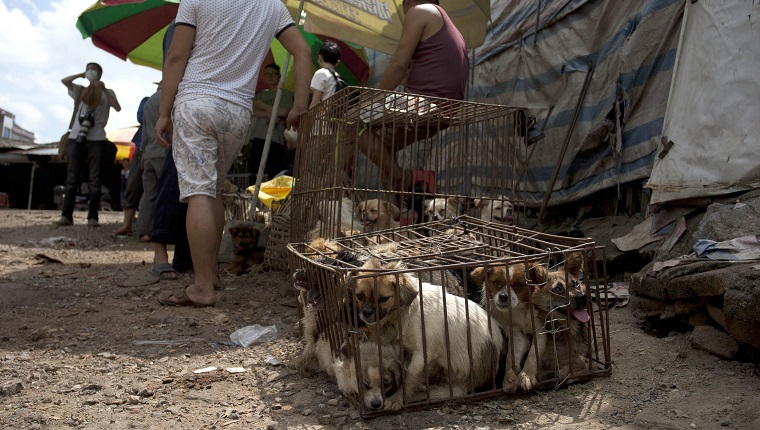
[55,63,121,227]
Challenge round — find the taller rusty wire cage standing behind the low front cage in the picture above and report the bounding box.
[290,87,526,242]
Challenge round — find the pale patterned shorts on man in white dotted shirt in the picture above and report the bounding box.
[172,97,251,202]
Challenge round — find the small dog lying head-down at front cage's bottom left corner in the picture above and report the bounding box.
[333,341,401,410]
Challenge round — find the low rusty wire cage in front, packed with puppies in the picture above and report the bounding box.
[288,215,611,417]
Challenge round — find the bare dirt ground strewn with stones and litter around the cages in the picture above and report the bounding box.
[0,210,760,429]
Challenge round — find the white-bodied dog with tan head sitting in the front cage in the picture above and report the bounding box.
[349,259,504,409]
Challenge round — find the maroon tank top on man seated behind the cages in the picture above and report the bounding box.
[406,5,470,100]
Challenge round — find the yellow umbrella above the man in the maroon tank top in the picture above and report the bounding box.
[287,0,491,54]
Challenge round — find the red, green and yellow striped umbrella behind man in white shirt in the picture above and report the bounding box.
[76,0,369,89]
